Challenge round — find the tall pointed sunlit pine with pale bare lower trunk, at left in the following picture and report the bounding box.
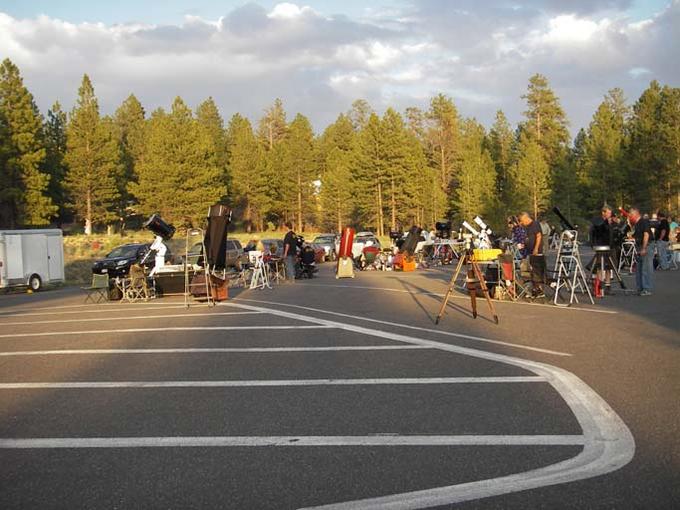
[65,75,122,235]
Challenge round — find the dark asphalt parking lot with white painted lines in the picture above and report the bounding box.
[0,265,680,509]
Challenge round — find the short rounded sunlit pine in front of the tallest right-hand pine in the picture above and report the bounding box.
[511,134,551,218]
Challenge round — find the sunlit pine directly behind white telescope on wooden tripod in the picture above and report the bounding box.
[451,119,496,220]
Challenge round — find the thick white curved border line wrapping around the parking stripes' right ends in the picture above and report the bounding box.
[220,303,635,510]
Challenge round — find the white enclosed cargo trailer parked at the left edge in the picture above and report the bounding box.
[0,229,64,290]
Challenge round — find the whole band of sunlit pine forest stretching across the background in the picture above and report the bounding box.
[0,59,680,235]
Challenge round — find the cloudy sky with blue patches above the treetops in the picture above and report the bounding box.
[0,0,680,134]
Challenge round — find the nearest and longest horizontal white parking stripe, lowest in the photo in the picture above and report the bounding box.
[0,434,585,449]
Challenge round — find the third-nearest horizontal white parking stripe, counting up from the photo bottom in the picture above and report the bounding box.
[0,345,432,356]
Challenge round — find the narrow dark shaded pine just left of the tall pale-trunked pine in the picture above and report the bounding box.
[43,101,67,224]
